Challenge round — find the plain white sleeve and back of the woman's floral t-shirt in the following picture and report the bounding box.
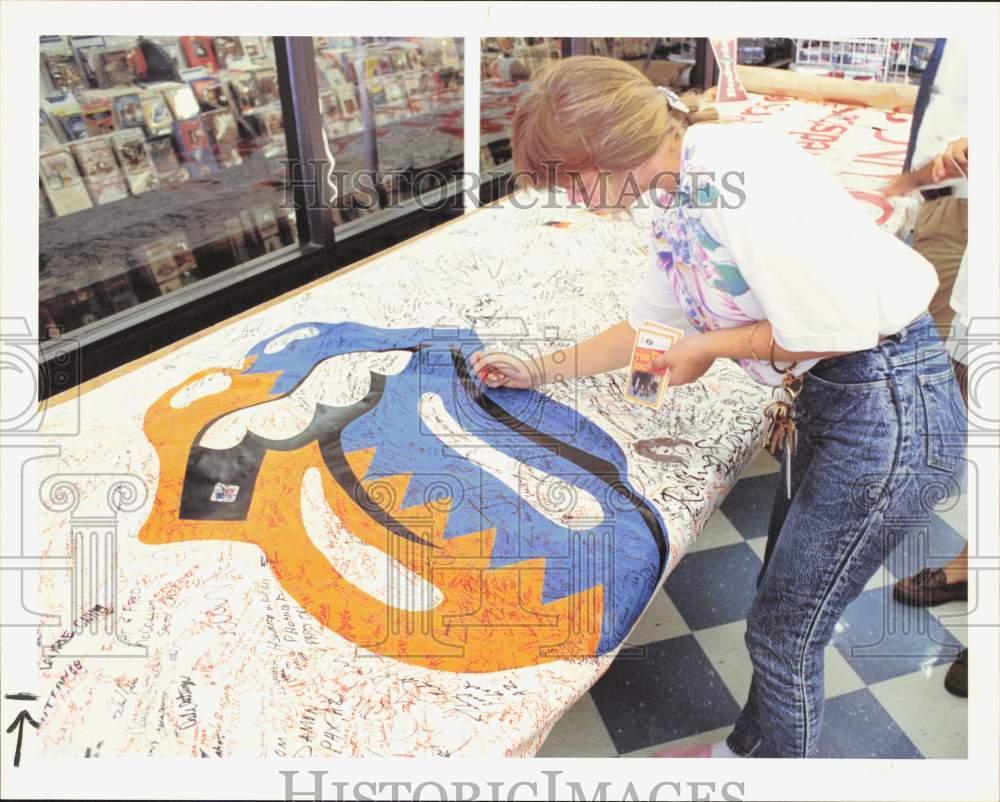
[699,125,937,352]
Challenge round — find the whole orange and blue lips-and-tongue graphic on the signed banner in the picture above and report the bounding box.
[139,323,669,671]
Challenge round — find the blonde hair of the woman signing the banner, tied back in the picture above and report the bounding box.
[511,56,718,195]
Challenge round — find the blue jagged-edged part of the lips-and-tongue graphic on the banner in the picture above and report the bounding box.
[245,322,669,654]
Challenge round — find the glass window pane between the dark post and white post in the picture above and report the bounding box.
[314,36,464,233]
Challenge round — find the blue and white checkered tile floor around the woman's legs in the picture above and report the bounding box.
[539,452,967,758]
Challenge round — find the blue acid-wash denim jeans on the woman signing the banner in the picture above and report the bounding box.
[727,314,966,757]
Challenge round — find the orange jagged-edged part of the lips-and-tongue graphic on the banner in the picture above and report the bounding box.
[139,369,604,672]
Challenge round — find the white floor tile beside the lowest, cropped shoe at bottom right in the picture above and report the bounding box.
[868,665,968,759]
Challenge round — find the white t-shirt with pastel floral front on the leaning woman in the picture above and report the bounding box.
[629,123,938,385]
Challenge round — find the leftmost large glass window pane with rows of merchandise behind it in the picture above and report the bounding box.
[39,36,297,339]
